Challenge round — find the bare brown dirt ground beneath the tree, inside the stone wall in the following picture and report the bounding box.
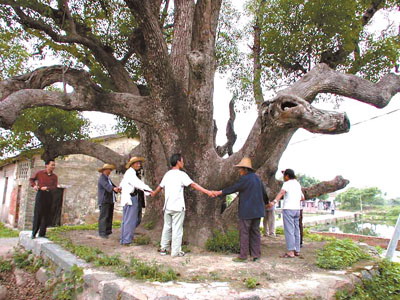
[67,229,334,288]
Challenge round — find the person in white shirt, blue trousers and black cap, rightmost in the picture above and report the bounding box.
[269,169,304,258]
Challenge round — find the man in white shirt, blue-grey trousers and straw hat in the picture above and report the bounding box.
[120,156,152,246]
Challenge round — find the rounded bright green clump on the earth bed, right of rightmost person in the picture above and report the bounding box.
[317,239,369,270]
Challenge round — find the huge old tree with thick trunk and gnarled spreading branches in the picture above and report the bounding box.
[0,0,400,244]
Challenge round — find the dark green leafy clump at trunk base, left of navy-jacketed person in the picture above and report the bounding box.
[206,229,240,253]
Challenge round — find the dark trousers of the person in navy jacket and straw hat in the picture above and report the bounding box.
[239,218,261,259]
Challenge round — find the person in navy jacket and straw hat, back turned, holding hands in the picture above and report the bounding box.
[214,157,268,262]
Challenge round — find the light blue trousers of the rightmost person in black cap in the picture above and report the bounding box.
[282,209,300,252]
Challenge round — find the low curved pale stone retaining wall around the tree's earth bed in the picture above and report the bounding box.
[19,231,384,300]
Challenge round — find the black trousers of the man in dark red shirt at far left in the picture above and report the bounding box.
[32,191,53,236]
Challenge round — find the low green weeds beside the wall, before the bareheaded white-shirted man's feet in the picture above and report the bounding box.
[117,258,178,282]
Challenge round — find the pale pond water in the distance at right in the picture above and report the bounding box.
[312,220,395,239]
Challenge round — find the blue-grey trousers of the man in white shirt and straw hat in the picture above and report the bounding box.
[121,196,142,244]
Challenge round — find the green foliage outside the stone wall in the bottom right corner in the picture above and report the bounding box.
[336,260,400,300]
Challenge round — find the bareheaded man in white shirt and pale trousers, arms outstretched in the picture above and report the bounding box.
[151,153,213,257]
